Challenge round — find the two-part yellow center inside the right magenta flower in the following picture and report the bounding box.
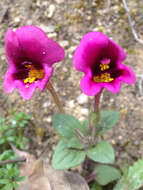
[93,59,114,82]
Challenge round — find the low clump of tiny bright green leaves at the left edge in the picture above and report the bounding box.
[0,112,30,190]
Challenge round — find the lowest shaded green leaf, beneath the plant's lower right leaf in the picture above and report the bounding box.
[94,165,121,185]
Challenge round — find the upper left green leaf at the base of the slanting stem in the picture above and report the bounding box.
[52,114,82,138]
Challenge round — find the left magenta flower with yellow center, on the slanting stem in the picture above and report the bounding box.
[4,26,64,100]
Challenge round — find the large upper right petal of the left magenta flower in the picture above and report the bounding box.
[15,26,64,66]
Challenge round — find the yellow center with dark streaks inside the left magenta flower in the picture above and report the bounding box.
[24,65,44,83]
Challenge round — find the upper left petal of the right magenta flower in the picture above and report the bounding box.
[74,32,108,72]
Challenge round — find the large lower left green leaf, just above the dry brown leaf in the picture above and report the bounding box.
[52,139,85,170]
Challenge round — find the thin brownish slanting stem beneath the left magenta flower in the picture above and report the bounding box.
[47,81,64,113]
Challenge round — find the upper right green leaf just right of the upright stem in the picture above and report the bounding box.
[97,110,120,135]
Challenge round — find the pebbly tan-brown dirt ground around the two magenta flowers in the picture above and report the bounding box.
[0,0,143,167]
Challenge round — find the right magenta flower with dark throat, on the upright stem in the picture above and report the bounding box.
[74,32,136,96]
